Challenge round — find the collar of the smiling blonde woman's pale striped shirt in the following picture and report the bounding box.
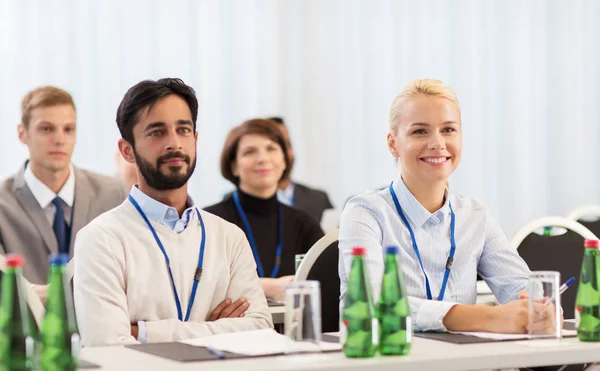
[392,177,450,228]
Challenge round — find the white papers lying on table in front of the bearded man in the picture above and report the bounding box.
[181,329,342,356]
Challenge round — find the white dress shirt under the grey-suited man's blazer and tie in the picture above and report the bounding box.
[23,163,75,226]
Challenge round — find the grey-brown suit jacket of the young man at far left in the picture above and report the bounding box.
[0,165,128,284]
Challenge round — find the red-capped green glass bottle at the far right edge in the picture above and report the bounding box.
[575,240,600,341]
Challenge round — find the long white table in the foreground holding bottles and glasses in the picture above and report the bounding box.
[81,338,600,371]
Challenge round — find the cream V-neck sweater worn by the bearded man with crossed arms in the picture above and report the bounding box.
[74,200,273,346]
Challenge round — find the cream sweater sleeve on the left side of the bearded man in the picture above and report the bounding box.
[73,225,138,346]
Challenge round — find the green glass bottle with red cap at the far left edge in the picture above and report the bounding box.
[0,254,35,371]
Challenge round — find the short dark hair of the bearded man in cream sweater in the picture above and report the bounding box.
[117,78,198,147]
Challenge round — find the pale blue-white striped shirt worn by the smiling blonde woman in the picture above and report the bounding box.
[339,178,530,331]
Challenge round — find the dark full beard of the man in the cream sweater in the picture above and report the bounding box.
[133,151,196,191]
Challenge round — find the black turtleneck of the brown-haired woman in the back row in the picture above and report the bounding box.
[205,189,323,277]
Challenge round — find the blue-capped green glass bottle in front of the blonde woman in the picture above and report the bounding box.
[378,246,412,355]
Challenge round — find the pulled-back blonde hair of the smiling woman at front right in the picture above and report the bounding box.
[390,79,460,134]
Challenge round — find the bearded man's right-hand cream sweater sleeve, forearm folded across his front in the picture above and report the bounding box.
[146,230,273,343]
